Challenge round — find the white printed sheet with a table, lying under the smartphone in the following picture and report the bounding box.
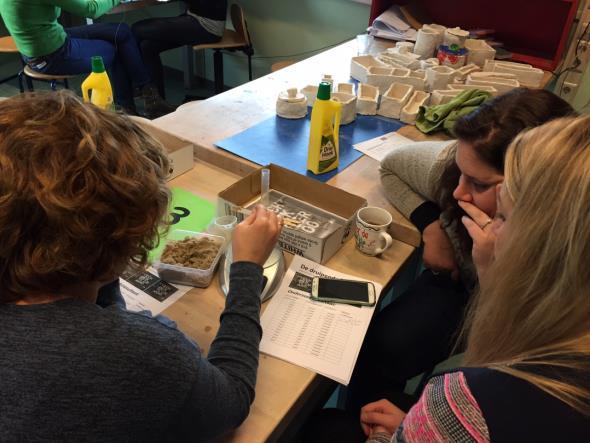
[260,256,382,385]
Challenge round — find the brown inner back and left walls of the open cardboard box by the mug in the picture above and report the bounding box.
[219,164,367,219]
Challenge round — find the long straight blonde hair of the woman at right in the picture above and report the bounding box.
[464,116,590,414]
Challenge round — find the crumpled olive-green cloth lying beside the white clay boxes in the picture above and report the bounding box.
[416,89,490,134]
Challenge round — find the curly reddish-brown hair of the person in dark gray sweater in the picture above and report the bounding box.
[0,91,170,303]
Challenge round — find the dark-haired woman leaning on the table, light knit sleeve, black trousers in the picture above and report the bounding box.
[347,88,573,414]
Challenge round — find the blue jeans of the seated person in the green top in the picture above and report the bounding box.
[24,23,150,110]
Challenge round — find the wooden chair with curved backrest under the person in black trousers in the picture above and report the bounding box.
[193,3,254,94]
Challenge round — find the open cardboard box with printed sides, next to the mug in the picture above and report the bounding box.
[217,164,367,263]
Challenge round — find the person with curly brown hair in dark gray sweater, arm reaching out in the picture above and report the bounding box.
[0,92,281,441]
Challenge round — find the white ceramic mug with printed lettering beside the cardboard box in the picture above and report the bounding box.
[354,206,393,255]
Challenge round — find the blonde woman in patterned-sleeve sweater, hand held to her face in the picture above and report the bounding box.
[361,116,590,442]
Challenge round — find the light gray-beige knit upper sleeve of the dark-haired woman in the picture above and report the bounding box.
[379,141,455,218]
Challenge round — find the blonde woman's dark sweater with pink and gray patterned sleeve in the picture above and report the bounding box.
[367,368,590,443]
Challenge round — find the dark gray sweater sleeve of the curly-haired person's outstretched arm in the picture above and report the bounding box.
[173,262,262,441]
